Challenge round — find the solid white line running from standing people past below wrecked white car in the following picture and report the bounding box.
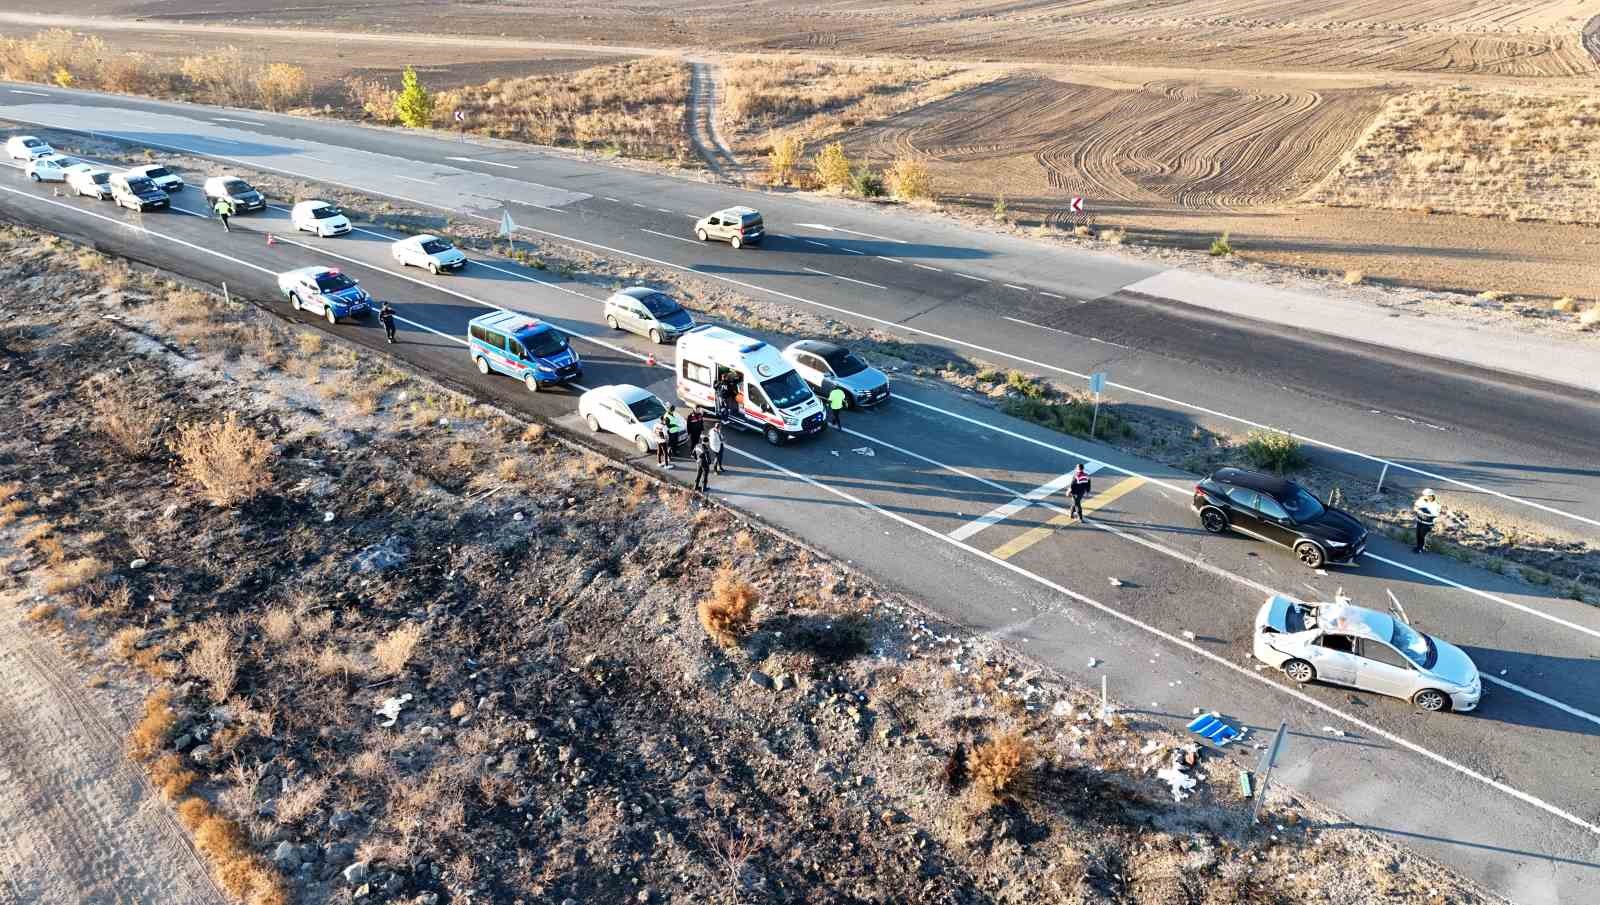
[733,425,1600,836]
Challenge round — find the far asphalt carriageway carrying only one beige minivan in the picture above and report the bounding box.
[0,85,1600,536]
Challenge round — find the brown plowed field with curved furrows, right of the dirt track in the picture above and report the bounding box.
[858,77,1384,209]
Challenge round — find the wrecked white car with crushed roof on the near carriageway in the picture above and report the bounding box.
[1254,595,1483,713]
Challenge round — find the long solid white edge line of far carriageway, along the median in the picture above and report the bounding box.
[40,115,1600,530]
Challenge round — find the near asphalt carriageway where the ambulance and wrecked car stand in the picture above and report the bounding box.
[0,171,1600,903]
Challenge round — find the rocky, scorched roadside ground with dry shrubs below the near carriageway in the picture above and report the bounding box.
[0,217,1510,905]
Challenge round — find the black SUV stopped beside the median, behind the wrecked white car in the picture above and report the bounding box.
[1192,468,1366,569]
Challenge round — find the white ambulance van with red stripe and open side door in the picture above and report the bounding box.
[677,323,824,446]
